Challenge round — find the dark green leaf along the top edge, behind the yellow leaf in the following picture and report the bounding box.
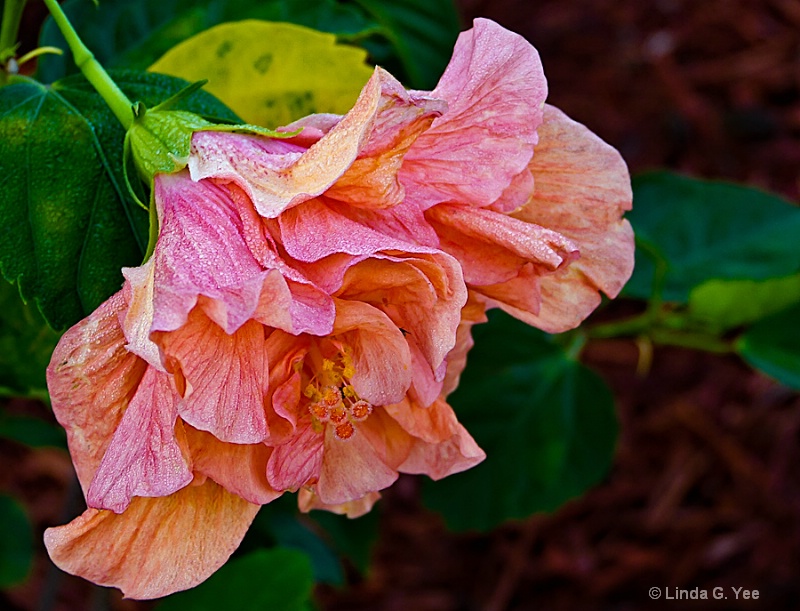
[39,0,378,82]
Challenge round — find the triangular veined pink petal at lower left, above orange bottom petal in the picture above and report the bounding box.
[86,367,192,513]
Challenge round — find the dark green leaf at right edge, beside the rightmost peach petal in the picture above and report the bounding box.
[625,172,800,303]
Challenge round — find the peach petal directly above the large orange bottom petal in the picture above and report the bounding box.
[185,426,281,505]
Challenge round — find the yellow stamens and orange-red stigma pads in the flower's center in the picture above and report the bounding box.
[303,348,372,441]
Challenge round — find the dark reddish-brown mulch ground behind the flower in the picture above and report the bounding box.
[0,0,800,611]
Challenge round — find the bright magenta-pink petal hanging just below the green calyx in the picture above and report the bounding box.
[151,171,267,333]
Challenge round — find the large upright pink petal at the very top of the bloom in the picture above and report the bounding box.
[400,19,547,208]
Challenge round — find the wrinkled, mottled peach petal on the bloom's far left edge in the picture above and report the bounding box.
[47,292,147,494]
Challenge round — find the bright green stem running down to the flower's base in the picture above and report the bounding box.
[44,0,133,129]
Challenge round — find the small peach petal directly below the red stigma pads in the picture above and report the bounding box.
[315,420,397,505]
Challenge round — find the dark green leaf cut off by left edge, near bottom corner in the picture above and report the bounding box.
[0,494,33,588]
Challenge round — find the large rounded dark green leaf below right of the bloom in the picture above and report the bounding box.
[423,312,617,531]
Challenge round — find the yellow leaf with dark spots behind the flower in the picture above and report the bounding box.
[150,19,372,127]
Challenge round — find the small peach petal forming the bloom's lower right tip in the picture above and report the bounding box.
[386,399,486,480]
